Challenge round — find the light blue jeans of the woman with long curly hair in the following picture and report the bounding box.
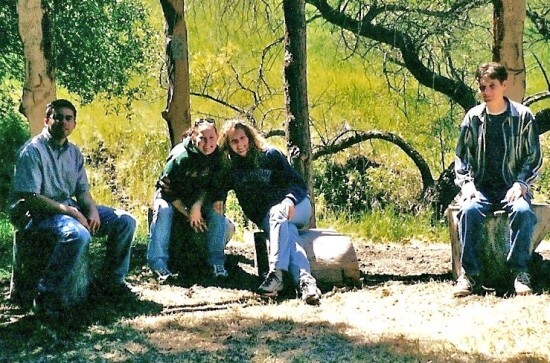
[261,198,311,283]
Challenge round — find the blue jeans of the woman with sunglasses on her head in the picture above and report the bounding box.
[147,195,231,270]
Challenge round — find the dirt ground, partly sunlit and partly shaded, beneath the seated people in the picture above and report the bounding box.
[0,237,550,362]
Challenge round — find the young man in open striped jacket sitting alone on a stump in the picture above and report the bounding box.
[454,63,542,297]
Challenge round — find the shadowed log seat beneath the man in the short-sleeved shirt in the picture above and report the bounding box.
[10,231,89,308]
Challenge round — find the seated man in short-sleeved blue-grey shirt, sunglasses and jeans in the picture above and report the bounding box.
[10,99,136,314]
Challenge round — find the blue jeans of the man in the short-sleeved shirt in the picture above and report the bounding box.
[29,206,136,295]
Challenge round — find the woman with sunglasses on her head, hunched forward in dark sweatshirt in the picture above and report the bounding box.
[147,119,232,283]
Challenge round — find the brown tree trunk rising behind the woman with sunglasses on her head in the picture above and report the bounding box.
[160,0,191,146]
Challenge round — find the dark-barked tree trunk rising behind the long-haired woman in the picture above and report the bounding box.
[283,0,316,227]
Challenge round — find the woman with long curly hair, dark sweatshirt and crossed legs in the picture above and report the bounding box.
[219,120,320,304]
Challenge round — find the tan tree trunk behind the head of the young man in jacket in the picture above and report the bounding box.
[493,0,526,103]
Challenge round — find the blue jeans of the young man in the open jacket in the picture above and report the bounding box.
[458,193,536,276]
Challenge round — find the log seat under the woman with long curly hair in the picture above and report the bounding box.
[254,229,360,290]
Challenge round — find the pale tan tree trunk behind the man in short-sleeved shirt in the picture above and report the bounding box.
[17,0,56,136]
